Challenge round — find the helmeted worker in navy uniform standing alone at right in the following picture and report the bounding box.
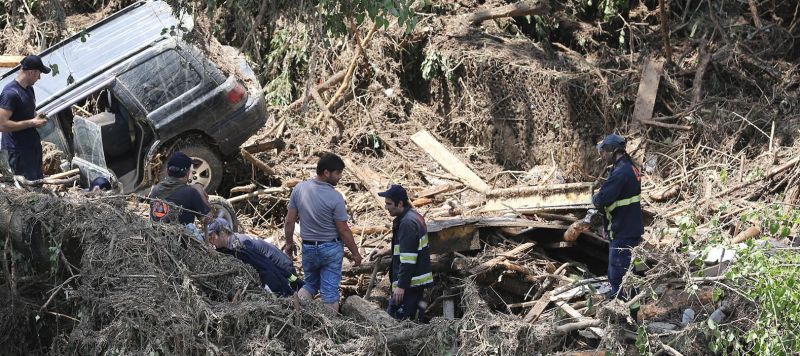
[592,134,644,299]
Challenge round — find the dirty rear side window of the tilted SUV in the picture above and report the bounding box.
[119,50,200,112]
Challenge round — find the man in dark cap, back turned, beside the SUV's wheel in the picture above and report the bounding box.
[150,152,211,236]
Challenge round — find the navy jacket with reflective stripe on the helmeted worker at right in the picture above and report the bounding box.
[592,157,644,240]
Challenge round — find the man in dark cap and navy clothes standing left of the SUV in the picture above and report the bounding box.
[0,56,50,180]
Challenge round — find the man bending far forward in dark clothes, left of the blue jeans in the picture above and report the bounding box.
[208,218,303,297]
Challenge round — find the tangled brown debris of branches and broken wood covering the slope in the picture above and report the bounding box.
[0,1,800,355]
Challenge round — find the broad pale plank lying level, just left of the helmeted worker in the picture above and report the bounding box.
[483,183,593,213]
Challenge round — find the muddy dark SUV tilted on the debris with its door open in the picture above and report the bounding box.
[0,1,266,193]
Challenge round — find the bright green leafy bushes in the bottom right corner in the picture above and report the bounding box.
[684,204,800,355]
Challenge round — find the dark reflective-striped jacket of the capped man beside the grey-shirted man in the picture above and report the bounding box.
[389,208,433,289]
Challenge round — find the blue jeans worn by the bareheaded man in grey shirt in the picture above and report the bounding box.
[302,241,344,304]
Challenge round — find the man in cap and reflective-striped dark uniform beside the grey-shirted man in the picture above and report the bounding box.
[378,185,433,320]
